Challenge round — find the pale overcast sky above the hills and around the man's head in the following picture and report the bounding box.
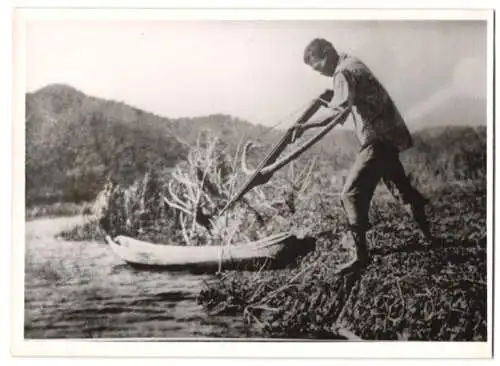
[26,20,487,125]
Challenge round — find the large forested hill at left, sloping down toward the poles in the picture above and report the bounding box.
[26,84,274,204]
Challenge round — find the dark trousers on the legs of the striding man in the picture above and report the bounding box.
[342,141,425,231]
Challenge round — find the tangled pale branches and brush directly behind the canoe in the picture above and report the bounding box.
[91,132,320,246]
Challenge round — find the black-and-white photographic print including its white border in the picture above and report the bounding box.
[10,9,494,357]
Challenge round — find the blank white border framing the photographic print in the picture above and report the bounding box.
[11,9,495,359]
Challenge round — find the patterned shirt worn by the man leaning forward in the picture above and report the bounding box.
[331,53,413,151]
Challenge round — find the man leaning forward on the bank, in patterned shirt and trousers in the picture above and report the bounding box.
[293,38,431,269]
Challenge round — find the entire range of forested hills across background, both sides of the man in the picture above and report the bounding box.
[26,85,486,205]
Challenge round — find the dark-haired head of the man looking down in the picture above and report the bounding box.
[304,38,339,76]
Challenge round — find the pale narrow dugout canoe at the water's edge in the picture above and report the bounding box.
[106,233,315,272]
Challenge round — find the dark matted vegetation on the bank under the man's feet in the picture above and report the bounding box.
[199,185,488,341]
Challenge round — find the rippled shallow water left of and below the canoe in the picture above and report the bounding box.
[24,217,249,338]
